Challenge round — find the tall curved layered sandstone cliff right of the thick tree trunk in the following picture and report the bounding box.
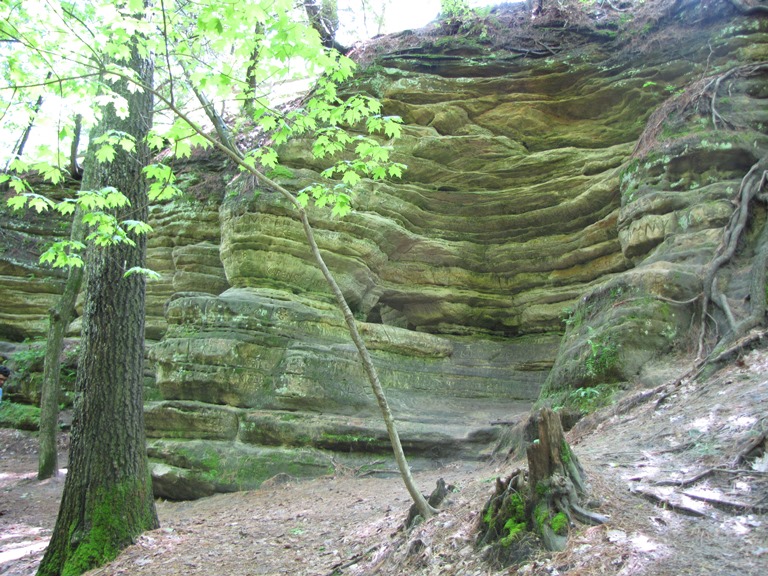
[0,1,768,498]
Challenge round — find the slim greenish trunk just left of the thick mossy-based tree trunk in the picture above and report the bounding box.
[37,212,87,480]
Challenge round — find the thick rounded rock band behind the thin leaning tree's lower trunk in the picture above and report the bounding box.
[151,289,557,414]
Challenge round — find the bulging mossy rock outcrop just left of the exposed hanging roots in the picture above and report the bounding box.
[545,14,768,399]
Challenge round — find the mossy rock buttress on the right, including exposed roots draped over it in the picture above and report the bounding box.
[545,10,768,398]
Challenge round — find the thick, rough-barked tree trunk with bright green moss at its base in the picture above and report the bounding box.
[38,45,158,576]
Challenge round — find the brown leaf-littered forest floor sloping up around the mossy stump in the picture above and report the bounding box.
[0,351,768,576]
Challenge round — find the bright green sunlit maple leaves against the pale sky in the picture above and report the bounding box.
[0,0,408,272]
